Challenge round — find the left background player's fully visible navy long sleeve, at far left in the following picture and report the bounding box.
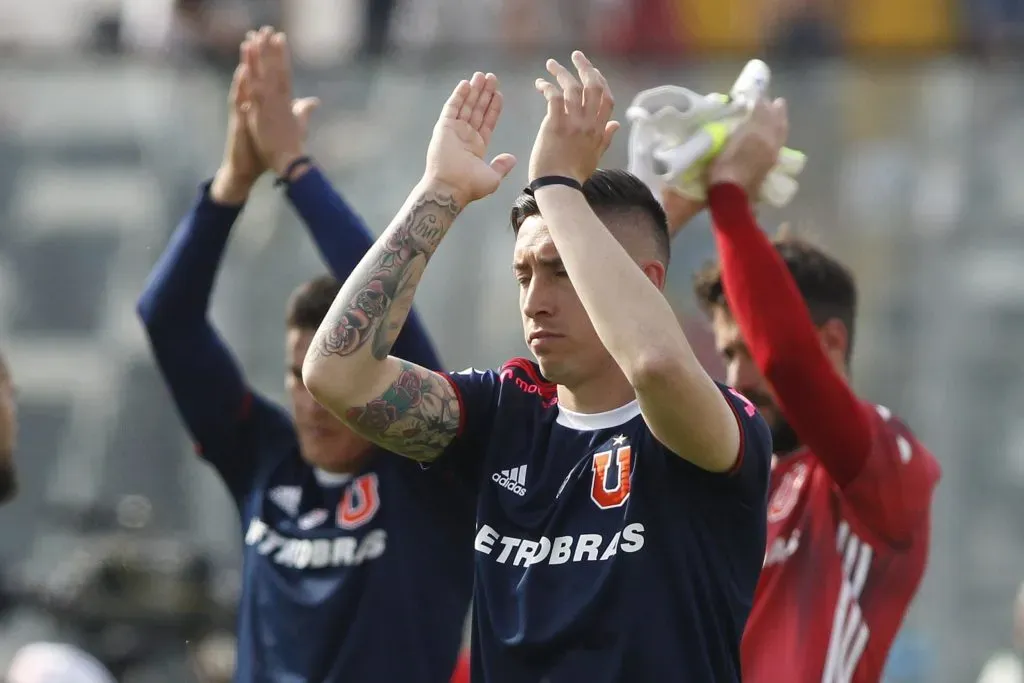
[137,182,289,497]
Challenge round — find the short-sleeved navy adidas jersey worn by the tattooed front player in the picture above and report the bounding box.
[442,359,771,683]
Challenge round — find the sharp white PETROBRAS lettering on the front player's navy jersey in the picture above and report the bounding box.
[473,522,644,566]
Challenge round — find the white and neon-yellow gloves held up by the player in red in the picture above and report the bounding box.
[626,59,807,207]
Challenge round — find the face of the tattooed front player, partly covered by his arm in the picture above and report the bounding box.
[512,216,614,387]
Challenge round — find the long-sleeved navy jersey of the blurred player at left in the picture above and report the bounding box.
[138,174,473,683]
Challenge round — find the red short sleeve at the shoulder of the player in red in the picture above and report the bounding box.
[840,403,941,545]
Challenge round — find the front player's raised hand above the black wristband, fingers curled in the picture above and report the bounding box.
[529,50,618,182]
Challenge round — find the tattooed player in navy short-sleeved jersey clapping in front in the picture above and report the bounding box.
[303,52,777,683]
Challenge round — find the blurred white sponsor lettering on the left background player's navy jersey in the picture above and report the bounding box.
[246,517,387,569]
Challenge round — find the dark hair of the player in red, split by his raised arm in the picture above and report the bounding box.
[693,232,857,360]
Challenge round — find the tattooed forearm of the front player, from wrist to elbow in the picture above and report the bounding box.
[314,193,461,360]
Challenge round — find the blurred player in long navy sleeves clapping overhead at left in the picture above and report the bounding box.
[138,29,473,683]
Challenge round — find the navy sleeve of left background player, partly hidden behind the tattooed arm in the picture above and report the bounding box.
[288,167,441,371]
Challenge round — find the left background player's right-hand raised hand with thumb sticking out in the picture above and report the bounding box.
[243,27,319,175]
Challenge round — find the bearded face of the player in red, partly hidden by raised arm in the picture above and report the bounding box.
[712,307,799,453]
